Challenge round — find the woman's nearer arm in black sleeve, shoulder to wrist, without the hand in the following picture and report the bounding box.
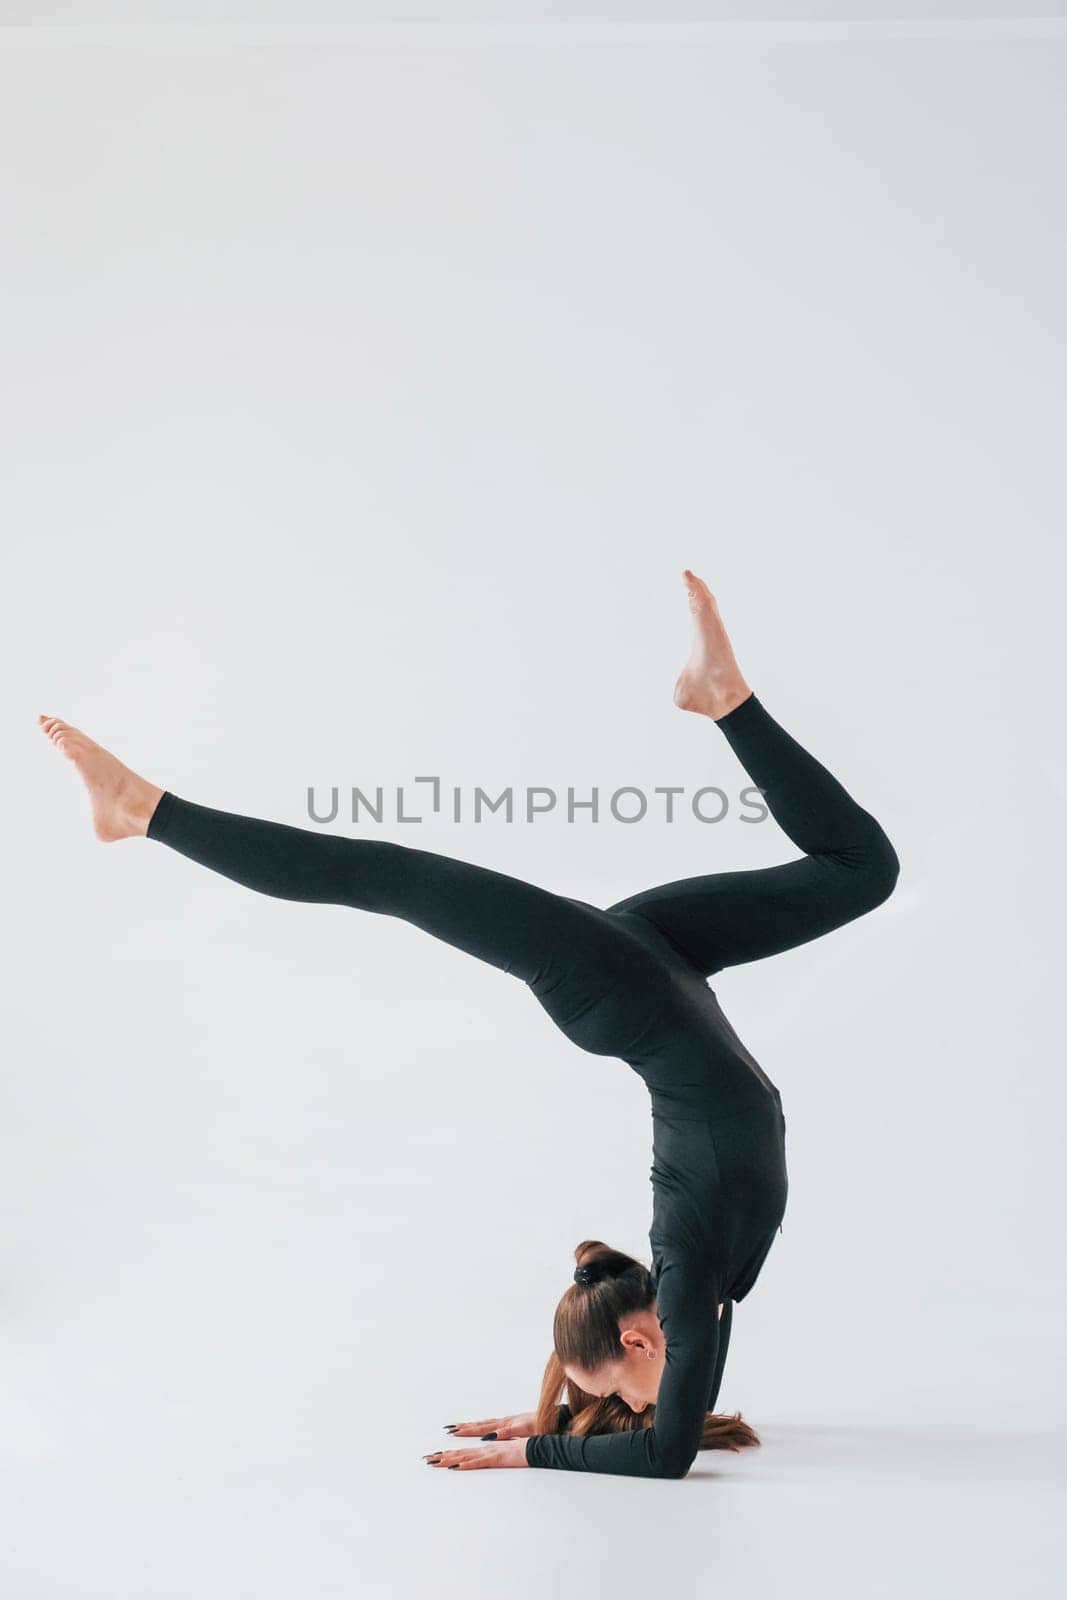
[526,1254,729,1478]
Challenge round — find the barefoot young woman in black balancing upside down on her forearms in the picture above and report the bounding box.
[38,571,899,1478]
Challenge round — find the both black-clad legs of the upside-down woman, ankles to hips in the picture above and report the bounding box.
[147,694,899,1054]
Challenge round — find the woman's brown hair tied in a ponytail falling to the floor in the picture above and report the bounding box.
[534,1238,760,1450]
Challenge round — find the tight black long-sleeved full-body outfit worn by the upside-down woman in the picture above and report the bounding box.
[139,694,899,1477]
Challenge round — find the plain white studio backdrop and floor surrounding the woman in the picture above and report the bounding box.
[0,18,1067,1600]
